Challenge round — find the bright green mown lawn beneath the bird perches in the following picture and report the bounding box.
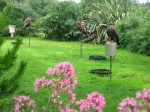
[2,38,150,112]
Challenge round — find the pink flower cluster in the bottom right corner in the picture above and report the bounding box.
[118,89,150,112]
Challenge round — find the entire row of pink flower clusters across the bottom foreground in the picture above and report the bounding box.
[10,62,150,112]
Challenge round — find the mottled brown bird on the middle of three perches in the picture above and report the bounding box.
[76,18,88,36]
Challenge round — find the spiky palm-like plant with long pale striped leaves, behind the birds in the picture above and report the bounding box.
[85,0,135,42]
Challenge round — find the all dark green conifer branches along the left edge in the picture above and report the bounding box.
[0,2,27,111]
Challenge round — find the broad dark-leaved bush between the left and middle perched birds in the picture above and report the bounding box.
[35,1,79,40]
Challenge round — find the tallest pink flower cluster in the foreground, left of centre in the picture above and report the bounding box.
[34,62,77,112]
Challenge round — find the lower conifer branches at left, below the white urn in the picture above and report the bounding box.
[0,38,26,97]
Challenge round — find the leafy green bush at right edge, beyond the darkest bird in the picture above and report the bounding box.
[117,8,150,56]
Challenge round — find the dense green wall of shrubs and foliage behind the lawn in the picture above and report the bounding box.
[0,0,150,55]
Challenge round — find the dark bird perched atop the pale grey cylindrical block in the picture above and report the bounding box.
[106,25,120,45]
